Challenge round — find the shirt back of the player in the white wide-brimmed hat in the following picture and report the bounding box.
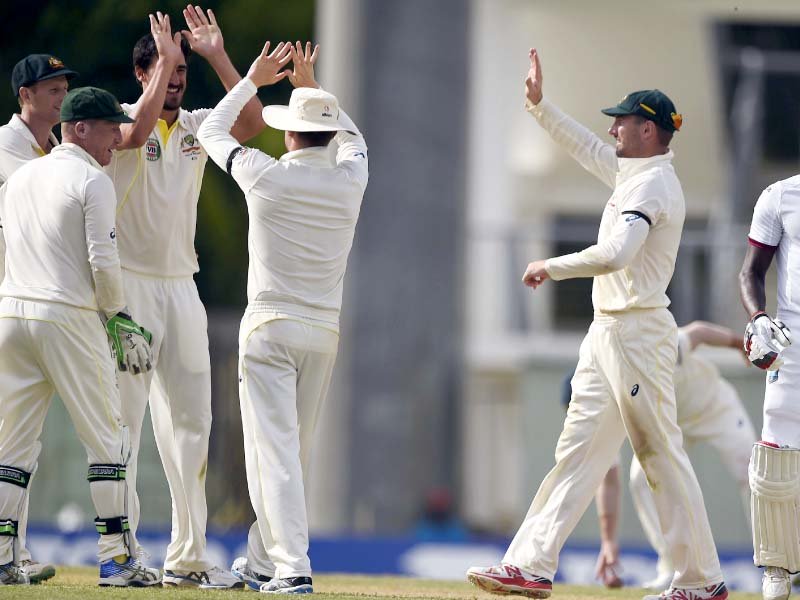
[247,148,365,319]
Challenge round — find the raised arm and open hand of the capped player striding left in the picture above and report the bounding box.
[525,48,618,188]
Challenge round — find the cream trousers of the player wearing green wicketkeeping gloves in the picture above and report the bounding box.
[0,298,129,564]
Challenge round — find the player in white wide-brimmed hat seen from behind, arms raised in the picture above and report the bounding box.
[200,42,368,593]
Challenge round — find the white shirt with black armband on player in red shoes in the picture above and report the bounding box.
[528,99,686,313]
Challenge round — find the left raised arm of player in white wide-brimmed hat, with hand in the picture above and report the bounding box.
[197,42,291,192]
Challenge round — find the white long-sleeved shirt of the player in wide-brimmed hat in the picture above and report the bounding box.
[200,78,369,327]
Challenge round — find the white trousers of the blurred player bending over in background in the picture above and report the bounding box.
[630,379,756,575]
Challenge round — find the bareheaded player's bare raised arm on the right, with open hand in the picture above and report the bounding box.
[182,4,266,142]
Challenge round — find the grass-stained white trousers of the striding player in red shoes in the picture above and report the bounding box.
[503,309,722,588]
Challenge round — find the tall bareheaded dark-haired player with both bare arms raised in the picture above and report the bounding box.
[106,5,264,589]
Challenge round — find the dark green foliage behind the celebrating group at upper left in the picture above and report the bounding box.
[0,0,314,306]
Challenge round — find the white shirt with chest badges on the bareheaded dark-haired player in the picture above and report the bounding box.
[105,104,211,278]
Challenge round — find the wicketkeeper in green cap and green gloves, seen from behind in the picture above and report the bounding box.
[0,88,161,587]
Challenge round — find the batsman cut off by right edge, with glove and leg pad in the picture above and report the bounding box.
[739,176,800,600]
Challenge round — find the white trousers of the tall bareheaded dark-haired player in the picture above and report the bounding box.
[119,269,212,571]
